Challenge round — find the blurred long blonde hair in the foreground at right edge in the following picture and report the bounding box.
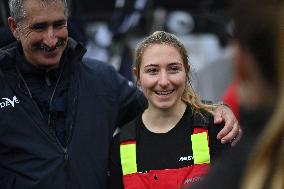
[241,2,284,189]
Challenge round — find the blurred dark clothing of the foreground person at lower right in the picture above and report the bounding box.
[190,108,272,189]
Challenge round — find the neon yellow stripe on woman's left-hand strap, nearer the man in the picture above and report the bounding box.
[120,143,137,175]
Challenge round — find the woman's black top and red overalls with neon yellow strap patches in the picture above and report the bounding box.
[109,107,229,189]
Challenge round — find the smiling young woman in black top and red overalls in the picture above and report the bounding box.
[109,31,230,189]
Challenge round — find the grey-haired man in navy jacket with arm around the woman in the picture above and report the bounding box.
[0,0,239,189]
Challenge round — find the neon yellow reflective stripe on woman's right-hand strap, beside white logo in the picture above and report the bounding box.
[191,132,210,164]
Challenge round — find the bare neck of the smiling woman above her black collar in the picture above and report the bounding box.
[142,102,187,133]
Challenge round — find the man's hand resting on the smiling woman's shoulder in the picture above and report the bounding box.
[214,105,242,146]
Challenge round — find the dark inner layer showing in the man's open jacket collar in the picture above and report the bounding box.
[16,44,70,148]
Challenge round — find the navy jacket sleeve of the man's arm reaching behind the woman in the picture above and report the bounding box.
[84,58,148,127]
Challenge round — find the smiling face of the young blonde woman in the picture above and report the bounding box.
[138,44,186,110]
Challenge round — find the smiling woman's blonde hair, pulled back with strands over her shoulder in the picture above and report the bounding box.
[135,31,216,112]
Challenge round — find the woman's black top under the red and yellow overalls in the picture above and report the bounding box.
[108,107,228,189]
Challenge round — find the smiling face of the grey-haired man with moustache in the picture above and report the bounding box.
[8,0,68,68]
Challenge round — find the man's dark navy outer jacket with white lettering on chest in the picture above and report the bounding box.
[0,39,146,189]
